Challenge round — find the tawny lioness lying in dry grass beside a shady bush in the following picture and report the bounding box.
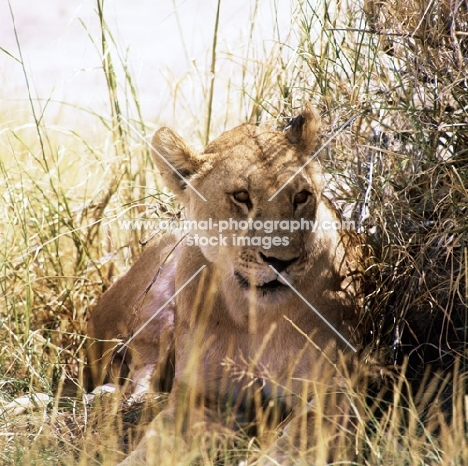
[90,105,361,464]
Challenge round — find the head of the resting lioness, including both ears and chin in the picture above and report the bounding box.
[153,110,328,306]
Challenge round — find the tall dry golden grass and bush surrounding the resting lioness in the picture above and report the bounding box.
[0,0,468,465]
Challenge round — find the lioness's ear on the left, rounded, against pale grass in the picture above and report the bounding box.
[151,127,201,200]
